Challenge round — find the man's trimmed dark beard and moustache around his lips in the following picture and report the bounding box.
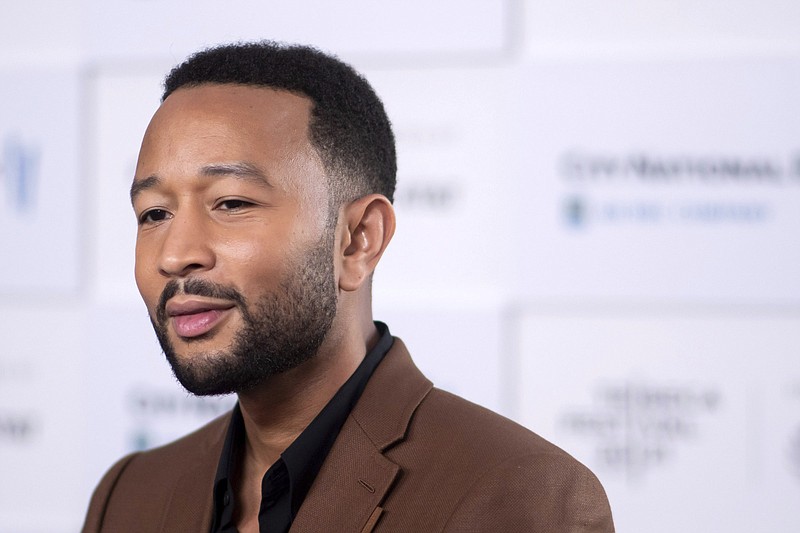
[151,232,337,396]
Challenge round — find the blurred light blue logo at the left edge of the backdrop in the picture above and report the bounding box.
[0,135,40,213]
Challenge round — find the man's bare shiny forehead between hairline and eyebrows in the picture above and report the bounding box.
[135,84,327,197]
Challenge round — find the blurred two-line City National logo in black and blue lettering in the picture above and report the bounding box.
[558,151,800,228]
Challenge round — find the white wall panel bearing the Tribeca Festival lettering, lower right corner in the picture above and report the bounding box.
[518,308,800,533]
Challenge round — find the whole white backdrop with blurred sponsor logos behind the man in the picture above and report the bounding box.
[0,0,800,533]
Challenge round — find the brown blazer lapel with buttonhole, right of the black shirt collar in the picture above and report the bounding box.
[290,339,432,533]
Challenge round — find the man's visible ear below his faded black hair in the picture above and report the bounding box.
[339,194,395,291]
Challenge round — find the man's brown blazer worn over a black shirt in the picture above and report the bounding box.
[83,339,614,533]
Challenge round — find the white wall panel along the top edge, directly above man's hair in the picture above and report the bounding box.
[87,0,508,61]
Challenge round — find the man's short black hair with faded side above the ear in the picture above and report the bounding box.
[161,41,397,209]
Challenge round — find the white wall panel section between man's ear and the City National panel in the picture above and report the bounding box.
[367,68,514,302]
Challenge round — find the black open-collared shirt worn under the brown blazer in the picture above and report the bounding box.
[211,322,394,533]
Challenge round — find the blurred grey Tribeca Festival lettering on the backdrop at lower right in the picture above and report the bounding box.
[559,382,721,480]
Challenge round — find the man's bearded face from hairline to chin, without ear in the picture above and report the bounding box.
[131,85,337,394]
